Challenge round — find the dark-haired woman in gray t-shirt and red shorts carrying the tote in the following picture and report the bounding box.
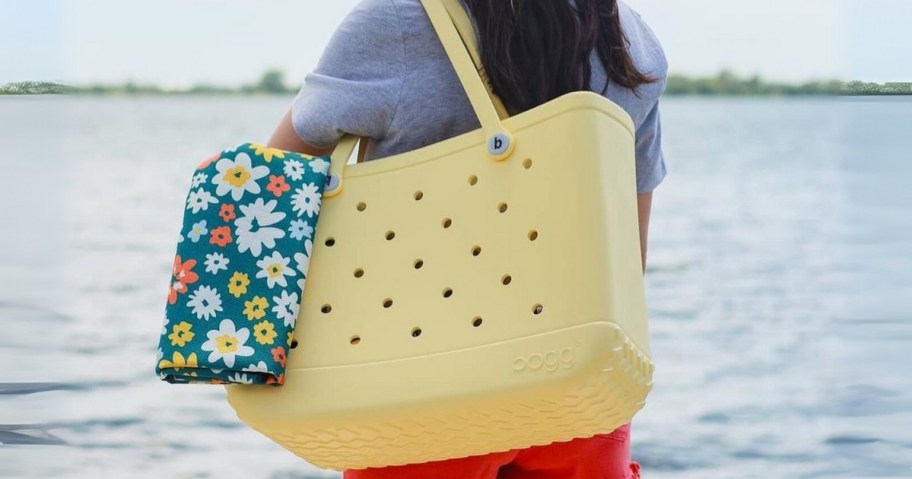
[269,0,667,479]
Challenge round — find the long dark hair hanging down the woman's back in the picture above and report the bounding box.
[465,0,658,113]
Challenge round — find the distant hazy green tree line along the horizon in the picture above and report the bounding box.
[0,70,912,96]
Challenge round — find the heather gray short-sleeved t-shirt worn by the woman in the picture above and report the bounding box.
[291,0,668,193]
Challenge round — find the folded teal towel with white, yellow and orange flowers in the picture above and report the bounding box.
[155,143,329,385]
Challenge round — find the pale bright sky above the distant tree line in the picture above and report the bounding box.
[0,0,912,87]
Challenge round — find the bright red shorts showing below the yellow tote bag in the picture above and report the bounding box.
[342,424,640,479]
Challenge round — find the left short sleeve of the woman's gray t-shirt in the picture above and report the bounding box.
[291,0,405,148]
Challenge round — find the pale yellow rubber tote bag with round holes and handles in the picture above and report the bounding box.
[226,0,653,470]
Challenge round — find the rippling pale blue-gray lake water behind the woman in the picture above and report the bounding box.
[0,97,912,479]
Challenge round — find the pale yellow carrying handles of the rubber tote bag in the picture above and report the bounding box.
[323,0,514,197]
